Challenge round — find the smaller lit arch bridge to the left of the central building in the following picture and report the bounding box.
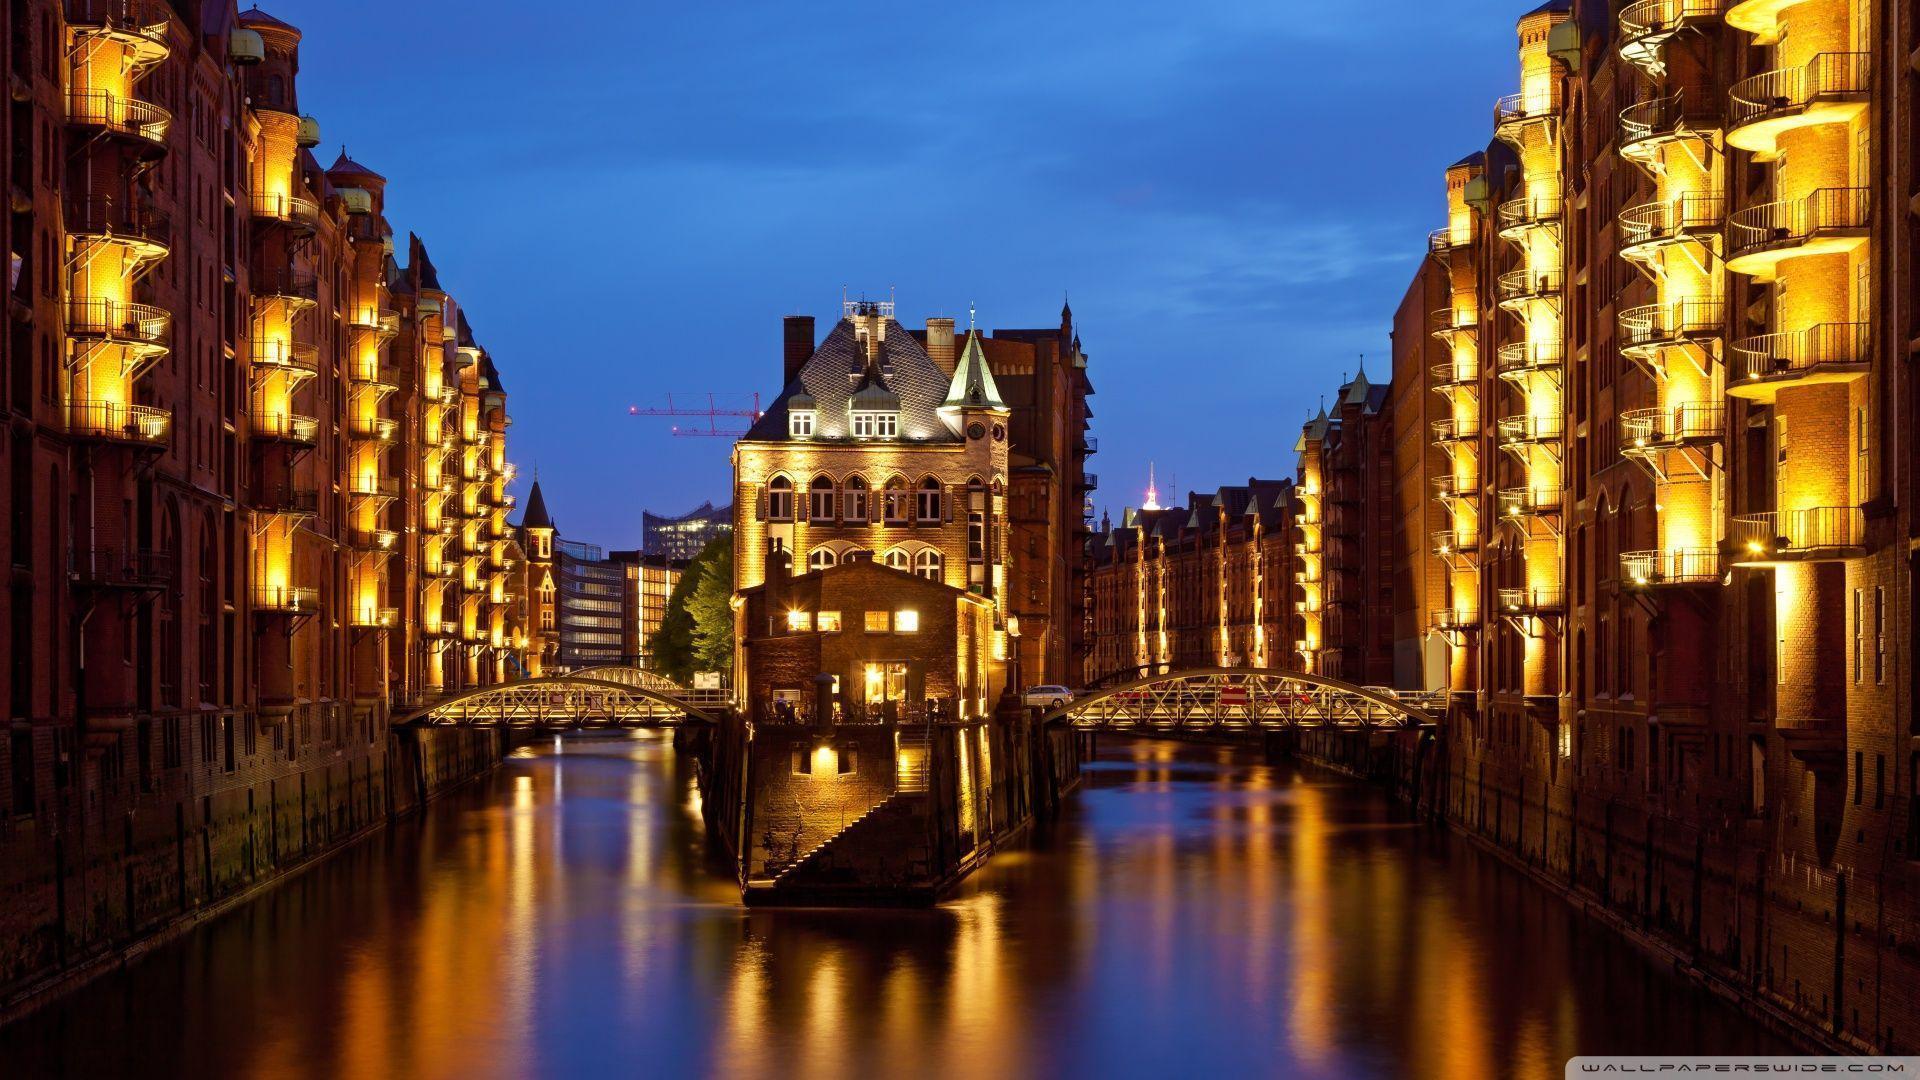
[397,669,718,728]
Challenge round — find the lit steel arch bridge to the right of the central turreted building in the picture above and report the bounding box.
[1043,667,1444,732]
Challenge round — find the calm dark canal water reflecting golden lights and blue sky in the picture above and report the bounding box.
[0,734,1784,1078]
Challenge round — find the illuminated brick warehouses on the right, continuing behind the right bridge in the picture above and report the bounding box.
[1085,0,1920,1047]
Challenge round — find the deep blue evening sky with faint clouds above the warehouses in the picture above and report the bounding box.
[280,0,1532,548]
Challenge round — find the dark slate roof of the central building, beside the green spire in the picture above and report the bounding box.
[747,319,960,442]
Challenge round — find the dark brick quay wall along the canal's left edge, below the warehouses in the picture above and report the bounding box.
[0,726,507,1024]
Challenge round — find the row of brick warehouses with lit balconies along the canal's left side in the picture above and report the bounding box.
[0,0,520,988]
